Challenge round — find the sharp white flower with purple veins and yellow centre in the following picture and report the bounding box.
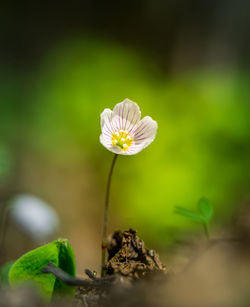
[100,99,157,155]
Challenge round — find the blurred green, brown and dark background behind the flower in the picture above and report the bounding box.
[0,0,250,273]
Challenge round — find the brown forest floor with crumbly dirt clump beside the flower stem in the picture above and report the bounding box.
[0,208,250,307]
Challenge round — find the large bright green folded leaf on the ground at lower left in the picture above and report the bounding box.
[9,239,76,299]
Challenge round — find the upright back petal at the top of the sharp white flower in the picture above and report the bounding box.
[112,99,141,131]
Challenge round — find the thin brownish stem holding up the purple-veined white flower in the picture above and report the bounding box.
[101,154,118,277]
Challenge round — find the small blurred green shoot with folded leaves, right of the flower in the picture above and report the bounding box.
[174,197,214,240]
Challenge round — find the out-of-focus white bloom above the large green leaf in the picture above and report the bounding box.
[10,194,59,240]
